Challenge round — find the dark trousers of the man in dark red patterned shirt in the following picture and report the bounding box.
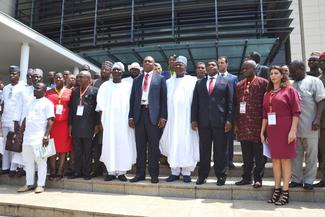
[240,141,266,182]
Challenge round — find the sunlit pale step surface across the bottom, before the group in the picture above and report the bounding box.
[0,186,325,217]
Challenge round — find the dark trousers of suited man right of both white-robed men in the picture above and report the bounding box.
[198,127,227,179]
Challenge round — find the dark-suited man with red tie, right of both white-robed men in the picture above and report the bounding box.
[191,60,233,186]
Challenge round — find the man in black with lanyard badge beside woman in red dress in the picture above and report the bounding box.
[69,70,100,180]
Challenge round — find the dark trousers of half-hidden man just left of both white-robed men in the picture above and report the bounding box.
[92,131,105,175]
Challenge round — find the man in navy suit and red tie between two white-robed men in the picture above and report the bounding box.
[129,56,167,183]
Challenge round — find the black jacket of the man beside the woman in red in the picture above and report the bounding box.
[69,86,100,138]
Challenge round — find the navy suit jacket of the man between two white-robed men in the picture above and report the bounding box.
[129,72,167,126]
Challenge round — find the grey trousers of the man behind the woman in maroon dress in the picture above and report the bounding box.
[292,138,318,184]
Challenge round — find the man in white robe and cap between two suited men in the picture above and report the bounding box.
[160,56,200,182]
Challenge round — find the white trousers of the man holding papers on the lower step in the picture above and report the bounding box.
[23,145,47,187]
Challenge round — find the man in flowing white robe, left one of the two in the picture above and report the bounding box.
[96,62,136,182]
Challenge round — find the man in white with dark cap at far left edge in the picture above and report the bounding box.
[2,66,25,177]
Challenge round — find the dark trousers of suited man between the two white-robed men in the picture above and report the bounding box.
[135,108,161,177]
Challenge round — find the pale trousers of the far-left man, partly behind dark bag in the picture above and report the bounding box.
[2,127,18,171]
